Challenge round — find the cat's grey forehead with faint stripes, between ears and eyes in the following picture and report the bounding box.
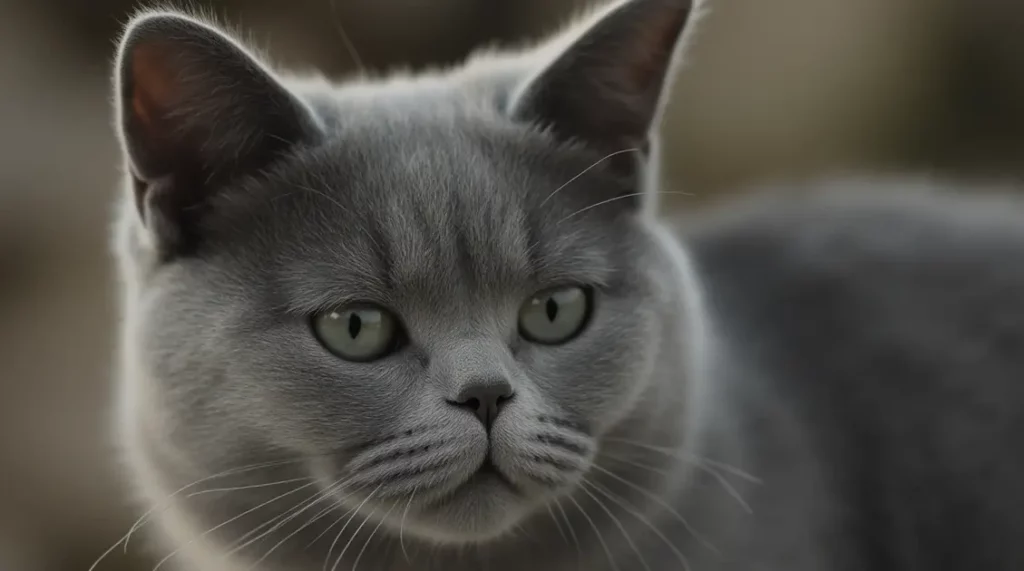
[230,109,615,313]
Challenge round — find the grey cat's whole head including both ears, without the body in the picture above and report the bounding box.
[116,0,691,542]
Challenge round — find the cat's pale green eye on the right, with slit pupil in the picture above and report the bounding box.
[519,287,592,345]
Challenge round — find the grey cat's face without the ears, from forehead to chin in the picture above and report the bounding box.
[143,117,658,536]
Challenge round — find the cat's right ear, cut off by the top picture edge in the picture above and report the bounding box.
[511,0,697,158]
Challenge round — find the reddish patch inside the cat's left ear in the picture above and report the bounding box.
[131,44,180,126]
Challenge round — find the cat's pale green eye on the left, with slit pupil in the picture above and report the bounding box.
[312,306,399,361]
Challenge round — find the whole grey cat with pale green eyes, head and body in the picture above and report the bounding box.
[99,0,1024,571]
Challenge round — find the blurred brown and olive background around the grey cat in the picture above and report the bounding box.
[6,0,1024,571]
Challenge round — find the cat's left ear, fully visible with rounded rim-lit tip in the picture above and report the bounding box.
[115,12,317,257]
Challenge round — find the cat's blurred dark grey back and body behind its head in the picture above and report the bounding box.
[686,181,1024,570]
